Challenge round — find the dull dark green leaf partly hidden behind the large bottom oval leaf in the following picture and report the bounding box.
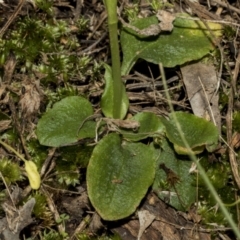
[153,140,196,211]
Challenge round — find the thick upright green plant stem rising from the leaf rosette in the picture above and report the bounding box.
[104,0,123,118]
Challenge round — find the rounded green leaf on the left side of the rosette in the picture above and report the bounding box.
[37,96,95,147]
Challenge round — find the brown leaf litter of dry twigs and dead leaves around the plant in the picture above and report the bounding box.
[0,0,239,240]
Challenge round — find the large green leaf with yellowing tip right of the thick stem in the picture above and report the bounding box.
[121,14,222,75]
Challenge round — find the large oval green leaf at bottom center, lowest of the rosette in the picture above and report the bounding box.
[87,133,156,220]
